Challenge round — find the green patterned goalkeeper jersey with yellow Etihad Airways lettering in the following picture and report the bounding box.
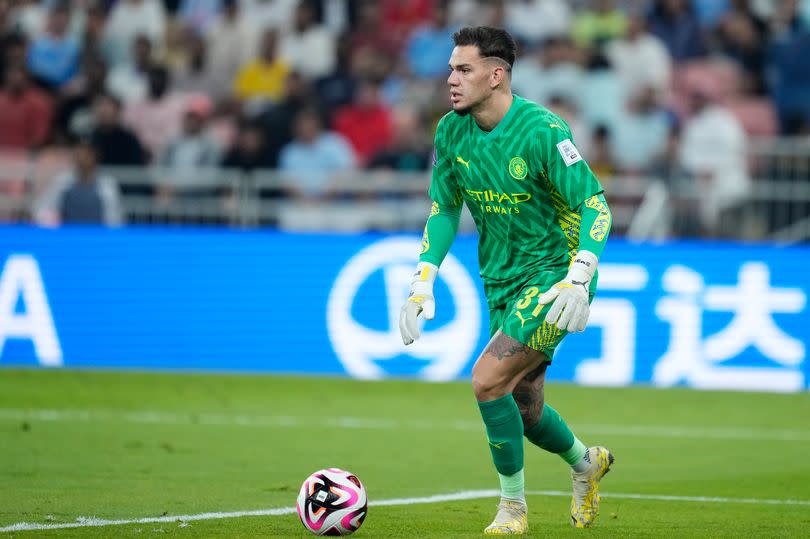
[430,95,606,305]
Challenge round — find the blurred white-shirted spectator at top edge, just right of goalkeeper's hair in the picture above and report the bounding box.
[504,0,571,46]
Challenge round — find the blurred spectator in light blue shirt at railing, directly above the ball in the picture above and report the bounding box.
[279,108,355,199]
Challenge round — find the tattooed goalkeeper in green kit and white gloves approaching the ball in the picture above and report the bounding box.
[400,27,613,535]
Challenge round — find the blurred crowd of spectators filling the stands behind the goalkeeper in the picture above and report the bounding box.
[0,0,810,234]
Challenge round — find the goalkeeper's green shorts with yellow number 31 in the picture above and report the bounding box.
[489,272,593,362]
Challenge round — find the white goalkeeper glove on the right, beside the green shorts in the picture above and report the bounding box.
[538,251,599,333]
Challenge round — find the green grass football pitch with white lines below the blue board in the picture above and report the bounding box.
[0,370,810,539]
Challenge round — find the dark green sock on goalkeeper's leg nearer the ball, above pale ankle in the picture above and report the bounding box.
[478,393,523,476]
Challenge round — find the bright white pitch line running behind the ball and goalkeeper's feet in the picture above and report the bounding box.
[0,490,810,533]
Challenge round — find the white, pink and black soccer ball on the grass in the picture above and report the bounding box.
[295,468,368,535]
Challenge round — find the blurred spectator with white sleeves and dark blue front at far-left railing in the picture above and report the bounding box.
[34,141,123,226]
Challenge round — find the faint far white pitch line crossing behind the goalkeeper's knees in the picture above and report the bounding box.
[0,408,810,442]
